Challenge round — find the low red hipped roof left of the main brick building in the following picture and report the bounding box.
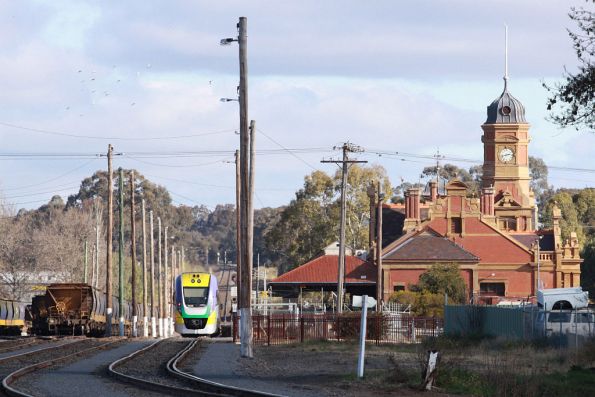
[270,255,376,284]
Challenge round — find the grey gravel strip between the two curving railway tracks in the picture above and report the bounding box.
[16,339,161,397]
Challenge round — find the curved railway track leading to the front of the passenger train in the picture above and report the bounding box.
[108,339,278,397]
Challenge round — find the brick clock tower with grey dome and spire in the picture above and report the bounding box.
[481,73,537,232]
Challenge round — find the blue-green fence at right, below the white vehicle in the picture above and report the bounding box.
[444,305,595,346]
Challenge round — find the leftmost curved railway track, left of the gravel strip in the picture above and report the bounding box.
[0,339,120,397]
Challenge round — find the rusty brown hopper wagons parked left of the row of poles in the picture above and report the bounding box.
[30,283,143,336]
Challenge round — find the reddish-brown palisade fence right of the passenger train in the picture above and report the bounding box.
[233,312,444,345]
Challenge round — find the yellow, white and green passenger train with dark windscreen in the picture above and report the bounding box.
[174,272,220,336]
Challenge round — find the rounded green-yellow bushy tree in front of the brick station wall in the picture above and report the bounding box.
[417,263,467,303]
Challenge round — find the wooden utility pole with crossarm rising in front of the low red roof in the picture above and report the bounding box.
[321,142,367,313]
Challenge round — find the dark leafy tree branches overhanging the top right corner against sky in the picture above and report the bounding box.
[543,0,595,132]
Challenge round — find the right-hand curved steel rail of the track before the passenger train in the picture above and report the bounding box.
[166,339,282,397]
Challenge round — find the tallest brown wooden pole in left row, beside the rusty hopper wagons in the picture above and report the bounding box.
[105,144,114,336]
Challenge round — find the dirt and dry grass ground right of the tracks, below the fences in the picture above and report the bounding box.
[236,339,595,397]
